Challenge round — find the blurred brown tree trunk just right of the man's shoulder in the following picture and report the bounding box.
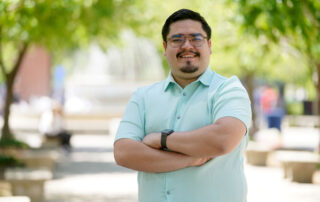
[245,73,259,140]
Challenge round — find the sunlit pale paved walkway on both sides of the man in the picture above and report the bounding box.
[45,135,320,202]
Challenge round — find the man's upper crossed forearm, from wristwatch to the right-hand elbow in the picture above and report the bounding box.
[167,117,246,157]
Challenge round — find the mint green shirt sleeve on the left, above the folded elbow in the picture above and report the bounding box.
[115,89,145,142]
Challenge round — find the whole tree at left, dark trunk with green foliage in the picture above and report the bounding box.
[0,0,132,143]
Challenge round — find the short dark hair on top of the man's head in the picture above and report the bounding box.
[162,9,211,42]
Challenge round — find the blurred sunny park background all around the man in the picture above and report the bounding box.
[0,0,320,202]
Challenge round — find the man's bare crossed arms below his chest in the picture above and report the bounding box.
[114,117,246,172]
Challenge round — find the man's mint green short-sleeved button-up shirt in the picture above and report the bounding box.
[115,68,251,202]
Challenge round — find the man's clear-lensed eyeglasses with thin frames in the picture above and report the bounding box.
[167,33,207,48]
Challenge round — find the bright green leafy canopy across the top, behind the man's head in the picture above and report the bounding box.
[0,0,320,142]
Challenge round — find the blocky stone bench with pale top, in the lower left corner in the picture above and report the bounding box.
[4,168,52,202]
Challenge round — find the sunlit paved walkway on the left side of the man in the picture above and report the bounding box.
[45,135,137,202]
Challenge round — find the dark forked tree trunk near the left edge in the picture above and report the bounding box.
[0,44,28,142]
